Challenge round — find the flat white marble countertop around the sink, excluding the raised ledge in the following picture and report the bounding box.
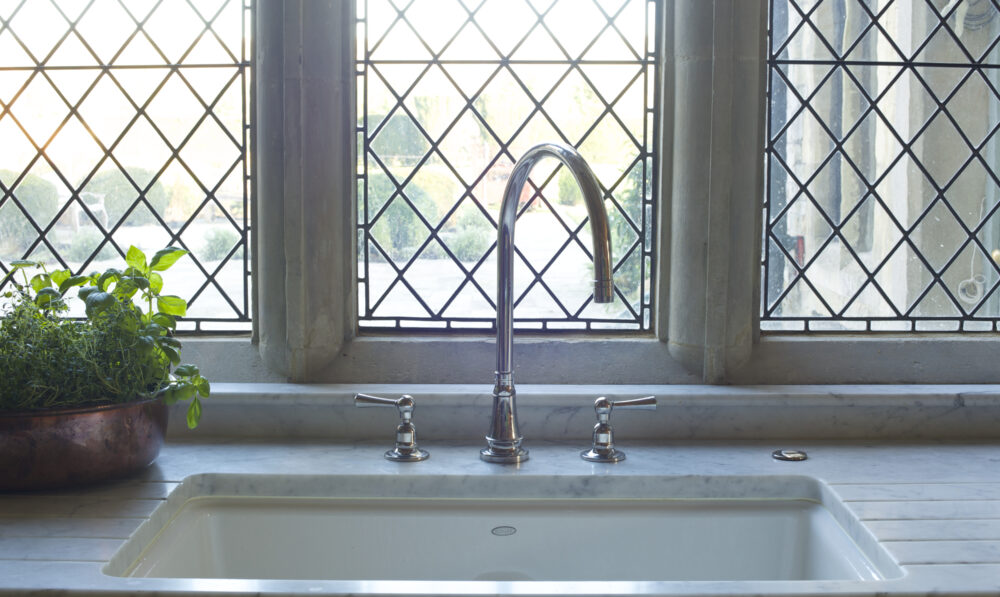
[0,436,1000,597]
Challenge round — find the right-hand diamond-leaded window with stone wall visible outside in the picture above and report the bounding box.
[761,0,1000,331]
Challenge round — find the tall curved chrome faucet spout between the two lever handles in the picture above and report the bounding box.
[479,143,614,464]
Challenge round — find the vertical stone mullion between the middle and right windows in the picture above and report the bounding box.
[668,0,767,383]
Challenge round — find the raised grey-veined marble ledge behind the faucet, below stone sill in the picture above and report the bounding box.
[171,383,1000,441]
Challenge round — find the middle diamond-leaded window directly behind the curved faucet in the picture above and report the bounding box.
[358,0,657,330]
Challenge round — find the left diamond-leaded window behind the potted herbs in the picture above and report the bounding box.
[0,0,252,330]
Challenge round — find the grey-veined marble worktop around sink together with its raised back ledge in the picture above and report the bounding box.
[0,384,1000,597]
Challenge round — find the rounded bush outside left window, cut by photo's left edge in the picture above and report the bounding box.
[0,170,59,249]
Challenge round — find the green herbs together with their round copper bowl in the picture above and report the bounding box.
[0,247,210,490]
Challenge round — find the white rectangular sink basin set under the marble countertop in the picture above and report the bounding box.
[105,475,902,593]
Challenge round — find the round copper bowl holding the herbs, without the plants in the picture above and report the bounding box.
[0,399,167,491]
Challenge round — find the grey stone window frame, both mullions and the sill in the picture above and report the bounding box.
[185,0,996,385]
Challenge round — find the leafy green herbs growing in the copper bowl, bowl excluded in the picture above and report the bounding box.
[0,247,211,428]
